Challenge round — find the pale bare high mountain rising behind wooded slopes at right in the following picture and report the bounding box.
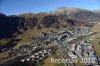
[50,7,100,22]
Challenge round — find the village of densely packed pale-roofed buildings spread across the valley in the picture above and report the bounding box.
[2,26,100,66]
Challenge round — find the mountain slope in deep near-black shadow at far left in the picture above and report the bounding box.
[0,13,19,38]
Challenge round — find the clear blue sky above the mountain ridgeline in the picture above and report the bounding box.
[0,0,100,15]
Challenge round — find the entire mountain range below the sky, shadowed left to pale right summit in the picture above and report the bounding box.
[0,7,100,38]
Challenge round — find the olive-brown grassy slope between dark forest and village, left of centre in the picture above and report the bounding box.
[16,28,55,47]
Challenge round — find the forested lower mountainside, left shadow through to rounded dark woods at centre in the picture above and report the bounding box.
[0,13,58,38]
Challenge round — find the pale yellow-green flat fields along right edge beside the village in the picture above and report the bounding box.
[85,24,100,56]
